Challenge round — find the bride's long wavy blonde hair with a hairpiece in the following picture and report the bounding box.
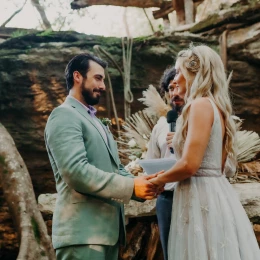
[175,45,237,159]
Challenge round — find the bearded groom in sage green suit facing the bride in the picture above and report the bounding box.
[45,54,157,260]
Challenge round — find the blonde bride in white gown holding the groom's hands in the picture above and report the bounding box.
[150,45,260,260]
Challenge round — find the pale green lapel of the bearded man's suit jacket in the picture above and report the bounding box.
[64,96,118,165]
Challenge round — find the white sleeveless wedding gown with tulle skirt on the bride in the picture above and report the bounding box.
[168,100,260,260]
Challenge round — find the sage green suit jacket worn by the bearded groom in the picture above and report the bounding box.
[45,96,134,249]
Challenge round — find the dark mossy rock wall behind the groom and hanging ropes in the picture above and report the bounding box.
[0,32,216,195]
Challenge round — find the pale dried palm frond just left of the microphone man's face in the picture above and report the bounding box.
[138,85,171,121]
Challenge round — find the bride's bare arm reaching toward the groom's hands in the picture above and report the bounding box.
[150,98,214,185]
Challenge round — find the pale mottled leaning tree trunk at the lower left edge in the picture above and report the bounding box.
[0,124,55,260]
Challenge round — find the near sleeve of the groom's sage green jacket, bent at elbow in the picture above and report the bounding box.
[45,107,134,203]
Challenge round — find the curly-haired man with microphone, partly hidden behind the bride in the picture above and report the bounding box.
[146,68,184,260]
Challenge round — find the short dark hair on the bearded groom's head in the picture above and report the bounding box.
[65,53,107,90]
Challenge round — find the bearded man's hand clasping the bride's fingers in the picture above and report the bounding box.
[134,172,164,200]
